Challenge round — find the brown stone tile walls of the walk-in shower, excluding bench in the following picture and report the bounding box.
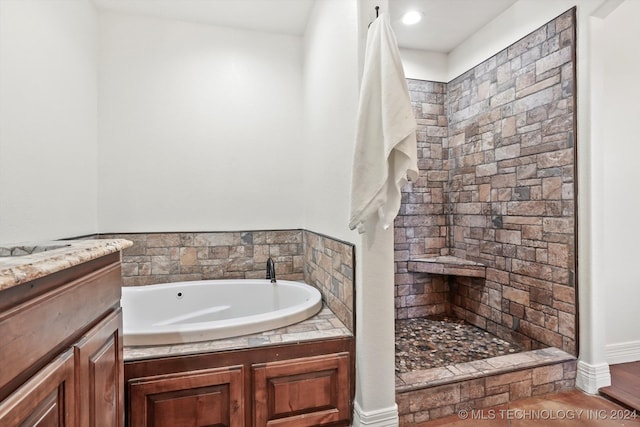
[395,10,576,355]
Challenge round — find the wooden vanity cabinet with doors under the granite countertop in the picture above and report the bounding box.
[0,253,124,427]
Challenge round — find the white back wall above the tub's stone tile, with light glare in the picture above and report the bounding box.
[99,12,304,232]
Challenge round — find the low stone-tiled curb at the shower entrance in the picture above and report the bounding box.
[396,347,577,426]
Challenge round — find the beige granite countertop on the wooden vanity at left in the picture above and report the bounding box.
[0,239,133,291]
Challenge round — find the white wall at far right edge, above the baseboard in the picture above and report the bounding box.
[599,0,640,363]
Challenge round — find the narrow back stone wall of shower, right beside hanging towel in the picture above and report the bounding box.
[394,79,450,319]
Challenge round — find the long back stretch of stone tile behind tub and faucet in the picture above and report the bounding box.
[102,230,303,286]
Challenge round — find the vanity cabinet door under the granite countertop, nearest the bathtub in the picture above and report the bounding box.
[75,309,124,427]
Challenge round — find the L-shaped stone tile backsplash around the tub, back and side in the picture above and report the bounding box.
[101,230,355,331]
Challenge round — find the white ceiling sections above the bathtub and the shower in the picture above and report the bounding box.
[94,0,516,53]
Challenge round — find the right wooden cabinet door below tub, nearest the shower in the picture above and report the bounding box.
[252,353,351,427]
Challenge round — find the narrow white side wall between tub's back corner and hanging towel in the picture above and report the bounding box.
[302,0,358,241]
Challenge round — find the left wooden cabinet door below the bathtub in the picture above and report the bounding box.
[129,366,245,427]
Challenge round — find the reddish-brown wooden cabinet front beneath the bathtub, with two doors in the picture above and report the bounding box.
[125,337,354,427]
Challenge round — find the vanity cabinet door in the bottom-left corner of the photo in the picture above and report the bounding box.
[0,350,75,427]
